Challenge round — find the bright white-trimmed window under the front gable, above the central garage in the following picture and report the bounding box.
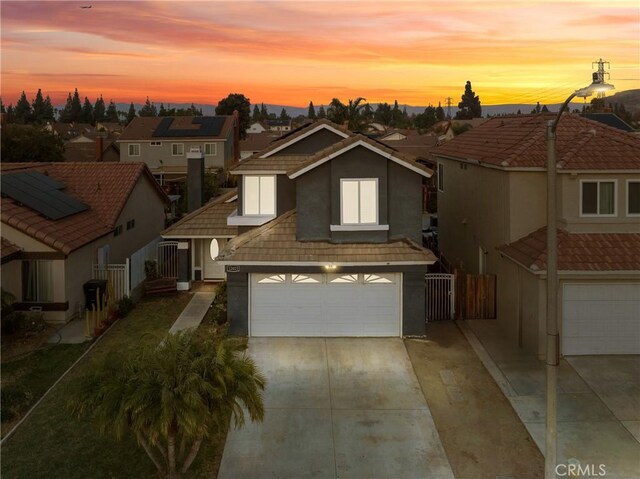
[340,178,378,225]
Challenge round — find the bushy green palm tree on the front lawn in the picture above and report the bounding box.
[69,331,265,478]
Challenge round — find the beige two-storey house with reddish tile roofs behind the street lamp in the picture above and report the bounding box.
[434,114,640,356]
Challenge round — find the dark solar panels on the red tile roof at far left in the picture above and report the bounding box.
[0,171,89,220]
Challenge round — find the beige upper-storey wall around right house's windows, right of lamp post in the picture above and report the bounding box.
[559,173,640,233]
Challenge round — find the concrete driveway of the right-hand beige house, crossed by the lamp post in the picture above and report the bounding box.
[458,320,640,479]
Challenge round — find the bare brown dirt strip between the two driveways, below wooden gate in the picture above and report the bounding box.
[405,321,544,479]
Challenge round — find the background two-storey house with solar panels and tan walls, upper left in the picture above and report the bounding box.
[118,116,240,184]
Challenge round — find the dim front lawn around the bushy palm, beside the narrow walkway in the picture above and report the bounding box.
[1,294,226,479]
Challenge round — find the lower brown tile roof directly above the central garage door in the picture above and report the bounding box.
[217,210,436,266]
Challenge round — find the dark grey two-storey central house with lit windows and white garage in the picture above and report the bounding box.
[208,120,436,336]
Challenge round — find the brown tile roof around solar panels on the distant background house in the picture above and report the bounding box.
[119,115,233,141]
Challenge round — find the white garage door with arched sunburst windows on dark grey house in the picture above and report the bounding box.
[249,273,402,336]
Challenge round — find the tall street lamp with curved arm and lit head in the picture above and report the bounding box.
[544,73,613,479]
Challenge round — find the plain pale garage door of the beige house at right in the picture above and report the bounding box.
[562,283,640,355]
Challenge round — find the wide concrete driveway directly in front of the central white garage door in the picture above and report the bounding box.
[218,338,453,479]
